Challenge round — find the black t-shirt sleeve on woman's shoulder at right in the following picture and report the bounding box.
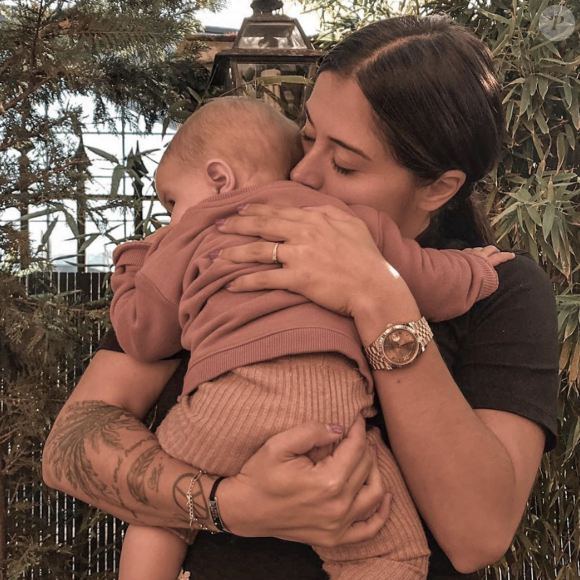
[453,255,559,451]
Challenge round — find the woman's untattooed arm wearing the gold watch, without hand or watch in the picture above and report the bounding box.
[355,296,545,573]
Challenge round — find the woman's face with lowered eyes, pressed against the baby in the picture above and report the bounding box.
[291,72,429,237]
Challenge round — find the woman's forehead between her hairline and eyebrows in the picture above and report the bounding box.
[306,72,384,159]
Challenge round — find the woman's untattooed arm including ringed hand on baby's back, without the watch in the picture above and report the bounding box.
[213,204,544,572]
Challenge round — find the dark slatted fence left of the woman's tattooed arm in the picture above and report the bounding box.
[0,272,125,580]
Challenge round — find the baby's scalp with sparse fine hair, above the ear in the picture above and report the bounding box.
[164,97,302,187]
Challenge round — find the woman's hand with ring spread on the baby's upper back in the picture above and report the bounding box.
[217,204,404,317]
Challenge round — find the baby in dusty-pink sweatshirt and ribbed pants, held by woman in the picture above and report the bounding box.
[111,97,512,580]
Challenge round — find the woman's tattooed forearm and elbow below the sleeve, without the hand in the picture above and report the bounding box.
[42,350,214,527]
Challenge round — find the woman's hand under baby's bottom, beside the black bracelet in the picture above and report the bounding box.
[218,416,392,547]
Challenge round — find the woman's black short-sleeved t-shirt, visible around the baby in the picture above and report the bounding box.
[100,243,559,580]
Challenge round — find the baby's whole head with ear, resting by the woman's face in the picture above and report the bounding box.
[155,97,302,222]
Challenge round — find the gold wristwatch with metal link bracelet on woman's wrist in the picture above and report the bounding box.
[365,317,433,371]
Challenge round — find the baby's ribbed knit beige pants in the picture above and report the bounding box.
[157,353,429,580]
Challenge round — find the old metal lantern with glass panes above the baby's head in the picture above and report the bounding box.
[211,0,324,119]
